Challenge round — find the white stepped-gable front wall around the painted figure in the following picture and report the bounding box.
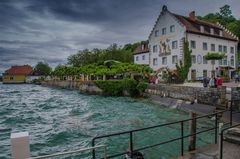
[149,12,186,70]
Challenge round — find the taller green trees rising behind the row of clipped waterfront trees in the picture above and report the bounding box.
[68,43,139,67]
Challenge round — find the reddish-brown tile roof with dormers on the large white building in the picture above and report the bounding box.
[172,13,238,41]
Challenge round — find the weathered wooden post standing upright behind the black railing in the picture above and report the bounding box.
[188,112,197,151]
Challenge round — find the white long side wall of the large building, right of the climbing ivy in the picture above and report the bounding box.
[187,33,237,80]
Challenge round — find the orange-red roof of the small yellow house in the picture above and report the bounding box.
[5,65,33,75]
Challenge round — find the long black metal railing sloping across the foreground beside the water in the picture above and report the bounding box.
[92,101,233,159]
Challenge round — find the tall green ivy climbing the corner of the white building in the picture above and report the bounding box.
[176,41,192,82]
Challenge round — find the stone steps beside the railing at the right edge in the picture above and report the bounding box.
[224,127,240,145]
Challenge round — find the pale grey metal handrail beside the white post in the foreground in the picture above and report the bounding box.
[28,145,107,159]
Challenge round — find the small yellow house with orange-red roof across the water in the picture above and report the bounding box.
[3,65,33,83]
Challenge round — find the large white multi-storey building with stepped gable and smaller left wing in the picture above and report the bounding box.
[134,6,238,80]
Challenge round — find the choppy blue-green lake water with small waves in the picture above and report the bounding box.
[0,84,215,158]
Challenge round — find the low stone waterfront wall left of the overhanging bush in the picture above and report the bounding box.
[42,80,103,95]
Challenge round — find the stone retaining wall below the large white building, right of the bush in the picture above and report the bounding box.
[146,84,226,106]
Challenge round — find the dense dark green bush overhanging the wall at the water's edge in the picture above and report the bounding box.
[95,79,142,97]
